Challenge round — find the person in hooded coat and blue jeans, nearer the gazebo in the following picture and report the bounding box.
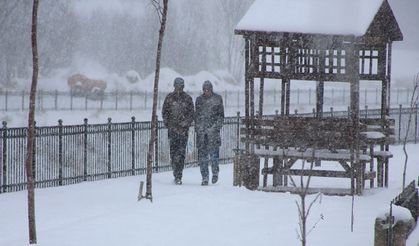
[195,80,224,185]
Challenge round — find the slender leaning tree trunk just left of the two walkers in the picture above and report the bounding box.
[145,0,169,201]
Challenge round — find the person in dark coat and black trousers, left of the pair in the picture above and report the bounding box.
[162,78,194,185]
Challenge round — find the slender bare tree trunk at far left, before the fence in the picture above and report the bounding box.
[25,0,38,244]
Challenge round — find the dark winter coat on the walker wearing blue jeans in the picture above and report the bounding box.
[195,93,224,149]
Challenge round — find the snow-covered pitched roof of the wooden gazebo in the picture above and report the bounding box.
[236,0,403,41]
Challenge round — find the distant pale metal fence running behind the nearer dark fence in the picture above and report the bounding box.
[0,88,413,111]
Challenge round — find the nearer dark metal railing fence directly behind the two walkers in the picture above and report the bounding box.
[0,107,418,193]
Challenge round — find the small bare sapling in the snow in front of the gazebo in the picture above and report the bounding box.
[290,161,323,246]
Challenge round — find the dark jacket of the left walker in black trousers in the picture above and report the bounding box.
[162,91,194,138]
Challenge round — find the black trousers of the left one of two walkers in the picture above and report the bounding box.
[169,133,188,179]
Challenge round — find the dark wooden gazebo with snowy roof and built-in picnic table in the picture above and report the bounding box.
[235,0,403,194]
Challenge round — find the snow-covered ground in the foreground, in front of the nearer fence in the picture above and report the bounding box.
[0,145,419,246]
